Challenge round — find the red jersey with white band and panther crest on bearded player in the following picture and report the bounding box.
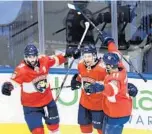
[11,55,66,107]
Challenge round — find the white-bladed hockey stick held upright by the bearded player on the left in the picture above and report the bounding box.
[55,22,90,101]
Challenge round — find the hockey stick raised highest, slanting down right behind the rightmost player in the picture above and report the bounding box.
[68,3,147,82]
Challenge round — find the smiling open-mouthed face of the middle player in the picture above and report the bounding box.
[83,53,94,66]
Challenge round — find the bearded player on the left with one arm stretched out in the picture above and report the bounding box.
[2,44,78,134]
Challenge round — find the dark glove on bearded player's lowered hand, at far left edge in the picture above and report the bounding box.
[1,82,14,96]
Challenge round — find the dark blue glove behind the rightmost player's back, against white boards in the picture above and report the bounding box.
[128,83,138,97]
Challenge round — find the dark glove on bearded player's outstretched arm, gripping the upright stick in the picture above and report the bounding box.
[65,47,81,59]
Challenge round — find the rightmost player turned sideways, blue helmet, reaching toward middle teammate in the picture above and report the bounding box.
[84,53,138,134]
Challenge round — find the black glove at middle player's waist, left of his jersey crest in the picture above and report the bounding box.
[71,74,81,90]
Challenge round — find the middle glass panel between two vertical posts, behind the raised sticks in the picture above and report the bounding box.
[44,1,111,68]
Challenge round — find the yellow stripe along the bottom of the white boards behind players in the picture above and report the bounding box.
[0,124,152,134]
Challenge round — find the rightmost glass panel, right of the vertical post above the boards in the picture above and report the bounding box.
[118,1,152,73]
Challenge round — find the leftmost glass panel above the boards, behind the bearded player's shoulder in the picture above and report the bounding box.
[0,1,38,67]
